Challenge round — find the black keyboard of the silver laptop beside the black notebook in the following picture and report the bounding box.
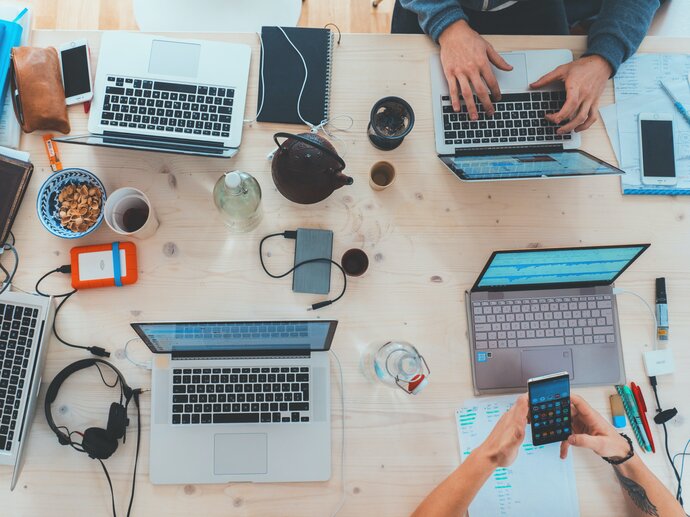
[101,76,235,138]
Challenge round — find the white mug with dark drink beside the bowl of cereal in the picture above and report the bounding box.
[104,187,159,239]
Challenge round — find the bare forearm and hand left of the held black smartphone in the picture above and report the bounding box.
[412,395,528,517]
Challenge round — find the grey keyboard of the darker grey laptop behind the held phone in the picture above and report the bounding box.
[472,295,616,349]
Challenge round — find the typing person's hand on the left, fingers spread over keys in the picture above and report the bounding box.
[438,20,513,120]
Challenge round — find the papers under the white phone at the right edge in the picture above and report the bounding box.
[599,54,690,195]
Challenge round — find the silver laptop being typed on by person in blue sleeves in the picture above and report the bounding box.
[431,50,623,181]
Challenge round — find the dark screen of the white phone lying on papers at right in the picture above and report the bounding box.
[640,120,676,178]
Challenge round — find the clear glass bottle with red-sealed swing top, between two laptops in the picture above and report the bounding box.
[362,341,431,395]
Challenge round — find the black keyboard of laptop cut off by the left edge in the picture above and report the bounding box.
[0,303,38,451]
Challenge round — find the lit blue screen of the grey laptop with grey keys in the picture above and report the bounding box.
[476,245,646,288]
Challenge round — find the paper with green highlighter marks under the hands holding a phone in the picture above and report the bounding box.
[456,395,580,517]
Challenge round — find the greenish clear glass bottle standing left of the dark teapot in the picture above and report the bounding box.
[213,171,262,233]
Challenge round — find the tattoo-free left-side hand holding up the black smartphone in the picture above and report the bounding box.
[478,395,529,468]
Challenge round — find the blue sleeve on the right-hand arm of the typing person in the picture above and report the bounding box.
[584,0,659,75]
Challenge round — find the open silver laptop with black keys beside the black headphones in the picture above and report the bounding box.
[132,320,337,484]
